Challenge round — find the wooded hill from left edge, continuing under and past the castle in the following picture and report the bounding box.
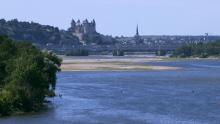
[0,19,116,53]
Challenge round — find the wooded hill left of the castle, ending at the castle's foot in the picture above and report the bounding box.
[0,19,80,48]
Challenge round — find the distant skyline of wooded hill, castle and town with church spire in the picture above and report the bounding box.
[0,19,220,54]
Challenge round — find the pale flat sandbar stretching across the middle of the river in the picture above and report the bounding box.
[61,55,181,71]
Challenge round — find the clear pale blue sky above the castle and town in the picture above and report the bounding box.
[0,0,220,36]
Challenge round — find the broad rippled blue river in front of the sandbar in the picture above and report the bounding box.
[0,60,220,124]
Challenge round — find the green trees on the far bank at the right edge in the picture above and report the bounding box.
[173,41,220,58]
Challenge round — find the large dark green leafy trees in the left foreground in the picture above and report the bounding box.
[0,36,61,116]
